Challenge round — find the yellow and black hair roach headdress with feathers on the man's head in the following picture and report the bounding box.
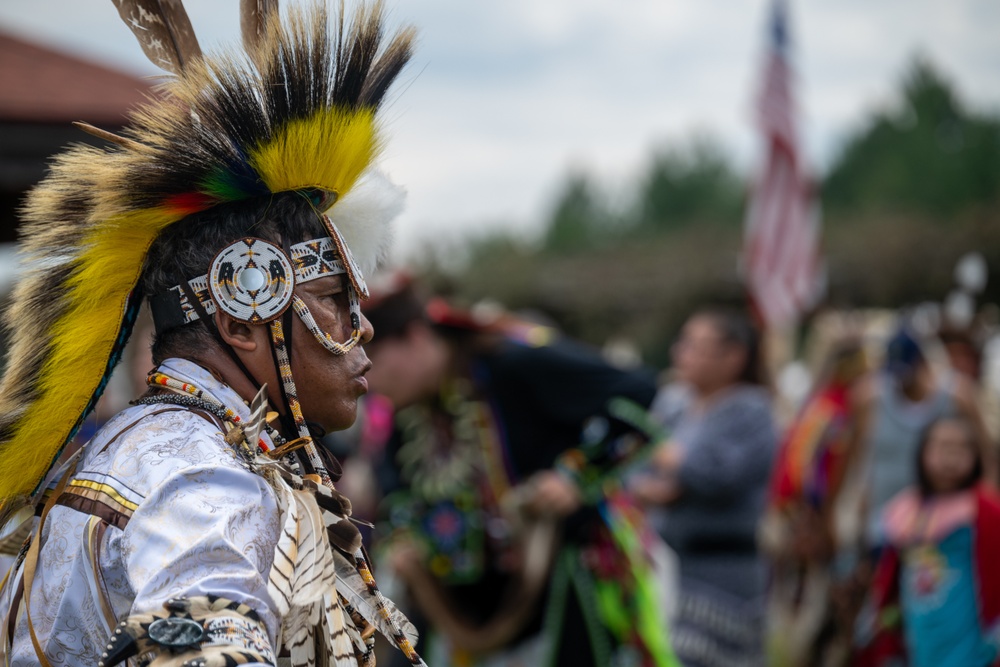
[0,0,413,501]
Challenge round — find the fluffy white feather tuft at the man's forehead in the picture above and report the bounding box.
[327,167,406,278]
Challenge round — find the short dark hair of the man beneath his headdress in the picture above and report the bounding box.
[139,192,327,364]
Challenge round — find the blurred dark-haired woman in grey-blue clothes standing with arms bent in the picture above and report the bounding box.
[634,309,777,667]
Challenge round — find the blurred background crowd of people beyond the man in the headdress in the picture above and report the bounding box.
[95,276,1000,667]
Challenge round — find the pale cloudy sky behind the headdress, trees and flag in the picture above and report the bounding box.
[0,0,1000,258]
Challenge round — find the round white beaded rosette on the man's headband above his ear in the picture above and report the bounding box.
[208,238,295,324]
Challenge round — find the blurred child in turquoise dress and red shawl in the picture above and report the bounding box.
[855,417,1000,667]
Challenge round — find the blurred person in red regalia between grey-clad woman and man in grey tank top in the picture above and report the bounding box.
[762,341,867,667]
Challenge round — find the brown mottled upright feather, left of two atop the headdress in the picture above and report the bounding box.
[114,0,201,74]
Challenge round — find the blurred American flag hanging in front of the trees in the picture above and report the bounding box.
[743,0,824,326]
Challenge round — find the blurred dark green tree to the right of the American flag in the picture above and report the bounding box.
[823,58,1000,217]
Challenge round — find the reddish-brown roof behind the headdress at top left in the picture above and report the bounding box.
[0,33,150,125]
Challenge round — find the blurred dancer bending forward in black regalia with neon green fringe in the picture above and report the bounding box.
[366,286,674,667]
